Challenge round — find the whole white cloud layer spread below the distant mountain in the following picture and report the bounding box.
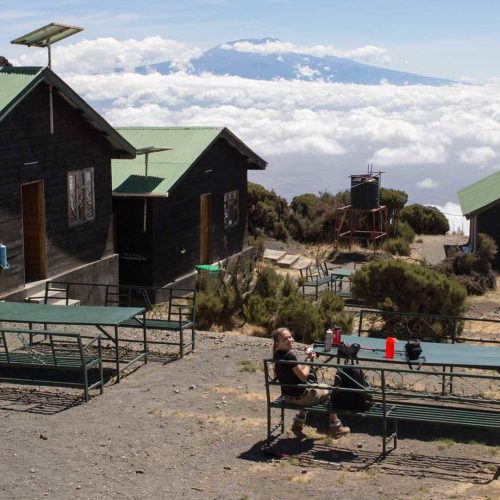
[12,37,500,232]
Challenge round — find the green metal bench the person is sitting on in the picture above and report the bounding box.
[264,359,500,458]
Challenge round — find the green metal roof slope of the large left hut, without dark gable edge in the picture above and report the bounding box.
[0,67,42,120]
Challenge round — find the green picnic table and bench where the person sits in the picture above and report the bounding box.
[264,335,500,457]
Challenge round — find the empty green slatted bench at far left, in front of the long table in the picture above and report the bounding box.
[0,328,104,401]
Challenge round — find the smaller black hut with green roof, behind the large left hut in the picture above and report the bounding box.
[113,127,266,286]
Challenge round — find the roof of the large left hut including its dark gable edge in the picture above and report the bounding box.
[0,66,135,158]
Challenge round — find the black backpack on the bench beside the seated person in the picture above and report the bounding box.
[330,366,373,411]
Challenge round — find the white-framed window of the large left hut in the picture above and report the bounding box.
[68,168,95,226]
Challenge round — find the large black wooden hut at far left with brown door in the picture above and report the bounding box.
[0,67,135,299]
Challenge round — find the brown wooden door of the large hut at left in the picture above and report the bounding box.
[21,181,47,282]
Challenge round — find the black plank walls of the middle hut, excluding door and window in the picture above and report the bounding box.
[114,138,247,286]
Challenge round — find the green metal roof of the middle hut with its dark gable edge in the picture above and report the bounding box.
[112,127,266,196]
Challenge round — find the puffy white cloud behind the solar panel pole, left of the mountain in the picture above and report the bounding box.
[12,36,201,74]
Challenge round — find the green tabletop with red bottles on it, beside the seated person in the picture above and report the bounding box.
[314,335,500,370]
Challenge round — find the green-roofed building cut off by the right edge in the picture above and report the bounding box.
[457,171,500,268]
